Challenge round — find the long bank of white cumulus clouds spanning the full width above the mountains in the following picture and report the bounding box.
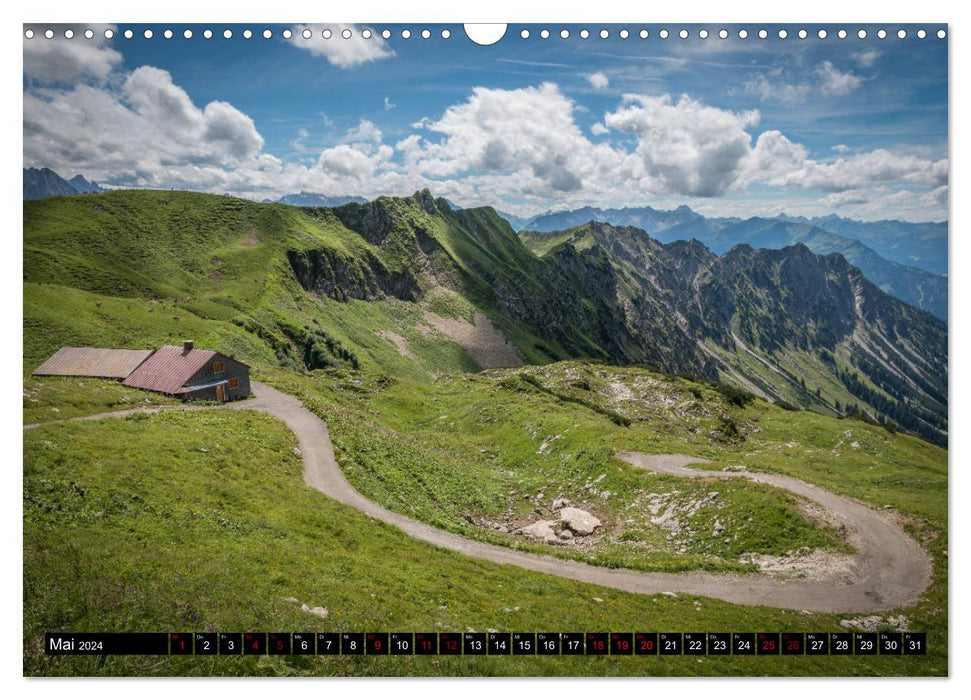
[23,66,948,219]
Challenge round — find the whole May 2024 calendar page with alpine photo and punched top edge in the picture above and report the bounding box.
[22,22,949,677]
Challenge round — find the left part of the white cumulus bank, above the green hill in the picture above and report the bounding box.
[23,57,418,199]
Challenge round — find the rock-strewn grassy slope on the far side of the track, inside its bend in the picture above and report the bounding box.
[262,363,947,571]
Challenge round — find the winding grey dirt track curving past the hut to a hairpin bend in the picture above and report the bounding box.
[24,382,931,612]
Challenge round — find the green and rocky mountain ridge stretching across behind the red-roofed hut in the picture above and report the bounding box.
[24,191,948,443]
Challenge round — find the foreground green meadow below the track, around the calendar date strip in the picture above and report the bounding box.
[24,411,947,676]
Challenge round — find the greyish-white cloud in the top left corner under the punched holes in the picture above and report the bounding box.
[24,25,121,83]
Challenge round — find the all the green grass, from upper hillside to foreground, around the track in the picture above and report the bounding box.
[24,192,947,675]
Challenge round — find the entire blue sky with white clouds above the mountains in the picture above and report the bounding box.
[24,25,948,220]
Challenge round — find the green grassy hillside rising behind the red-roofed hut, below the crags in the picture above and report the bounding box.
[24,191,536,379]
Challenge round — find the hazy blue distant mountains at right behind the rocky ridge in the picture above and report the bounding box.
[510,206,948,320]
